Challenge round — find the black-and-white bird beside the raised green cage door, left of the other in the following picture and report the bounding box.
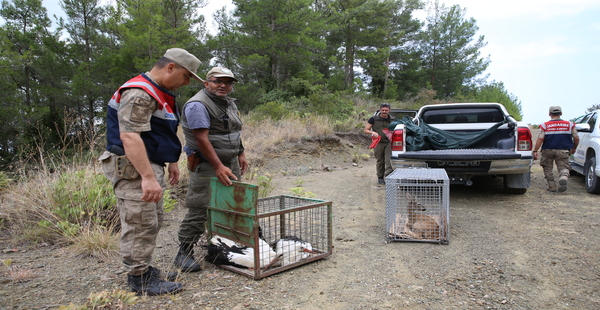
[204,235,277,269]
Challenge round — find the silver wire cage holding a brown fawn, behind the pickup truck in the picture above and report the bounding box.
[385,168,450,244]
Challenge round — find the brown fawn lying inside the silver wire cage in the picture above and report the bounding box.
[406,193,440,239]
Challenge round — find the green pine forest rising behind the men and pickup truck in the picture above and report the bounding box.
[0,0,521,171]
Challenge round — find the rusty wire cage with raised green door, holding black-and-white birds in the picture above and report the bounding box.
[207,178,333,279]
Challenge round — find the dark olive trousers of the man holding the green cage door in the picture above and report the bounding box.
[178,157,241,243]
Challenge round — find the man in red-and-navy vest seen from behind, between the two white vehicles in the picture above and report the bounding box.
[533,106,579,192]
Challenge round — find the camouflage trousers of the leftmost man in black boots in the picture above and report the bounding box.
[100,152,165,275]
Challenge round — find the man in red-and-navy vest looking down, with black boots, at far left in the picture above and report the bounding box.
[100,48,201,295]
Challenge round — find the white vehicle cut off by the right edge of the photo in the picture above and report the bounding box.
[570,110,600,194]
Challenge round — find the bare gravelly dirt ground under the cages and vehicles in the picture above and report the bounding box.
[0,136,600,309]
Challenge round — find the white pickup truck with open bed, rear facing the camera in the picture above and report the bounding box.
[390,103,533,194]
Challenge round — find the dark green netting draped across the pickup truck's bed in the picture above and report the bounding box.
[388,116,507,151]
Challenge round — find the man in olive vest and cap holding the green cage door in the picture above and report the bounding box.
[174,67,248,272]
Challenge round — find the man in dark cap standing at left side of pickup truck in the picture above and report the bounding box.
[363,103,396,184]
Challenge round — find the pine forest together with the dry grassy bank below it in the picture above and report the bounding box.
[0,0,522,262]
